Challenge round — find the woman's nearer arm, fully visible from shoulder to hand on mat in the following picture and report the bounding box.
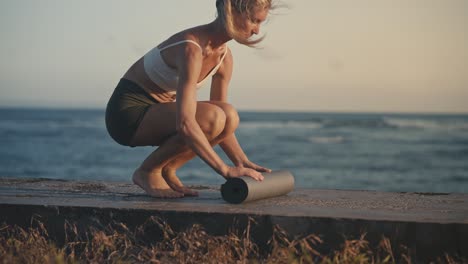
[176,45,263,180]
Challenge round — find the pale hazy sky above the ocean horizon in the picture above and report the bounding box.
[0,0,468,113]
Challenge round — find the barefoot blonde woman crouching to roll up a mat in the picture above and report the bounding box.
[106,0,272,198]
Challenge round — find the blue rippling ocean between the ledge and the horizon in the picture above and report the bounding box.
[0,108,468,193]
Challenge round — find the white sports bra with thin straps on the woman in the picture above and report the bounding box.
[143,39,227,94]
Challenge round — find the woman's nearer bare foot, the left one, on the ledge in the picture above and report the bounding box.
[132,168,184,198]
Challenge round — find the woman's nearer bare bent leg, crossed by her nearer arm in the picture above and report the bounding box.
[132,102,226,198]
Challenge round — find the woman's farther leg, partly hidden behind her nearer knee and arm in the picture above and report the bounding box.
[162,101,239,196]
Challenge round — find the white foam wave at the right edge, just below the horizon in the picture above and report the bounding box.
[384,118,468,130]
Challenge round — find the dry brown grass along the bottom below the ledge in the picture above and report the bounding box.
[0,218,466,263]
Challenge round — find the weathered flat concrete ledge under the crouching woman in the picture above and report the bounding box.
[0,178,468,261]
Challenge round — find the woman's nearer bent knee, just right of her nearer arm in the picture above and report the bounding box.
[197,104,226,139]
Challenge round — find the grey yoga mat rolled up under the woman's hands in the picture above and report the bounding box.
[221,170,294,204]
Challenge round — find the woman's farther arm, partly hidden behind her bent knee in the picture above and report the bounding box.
[210,49,271,172]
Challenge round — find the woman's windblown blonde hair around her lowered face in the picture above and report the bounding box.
[216,0,275,47]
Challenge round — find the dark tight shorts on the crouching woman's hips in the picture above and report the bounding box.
[106,78,159,146]
